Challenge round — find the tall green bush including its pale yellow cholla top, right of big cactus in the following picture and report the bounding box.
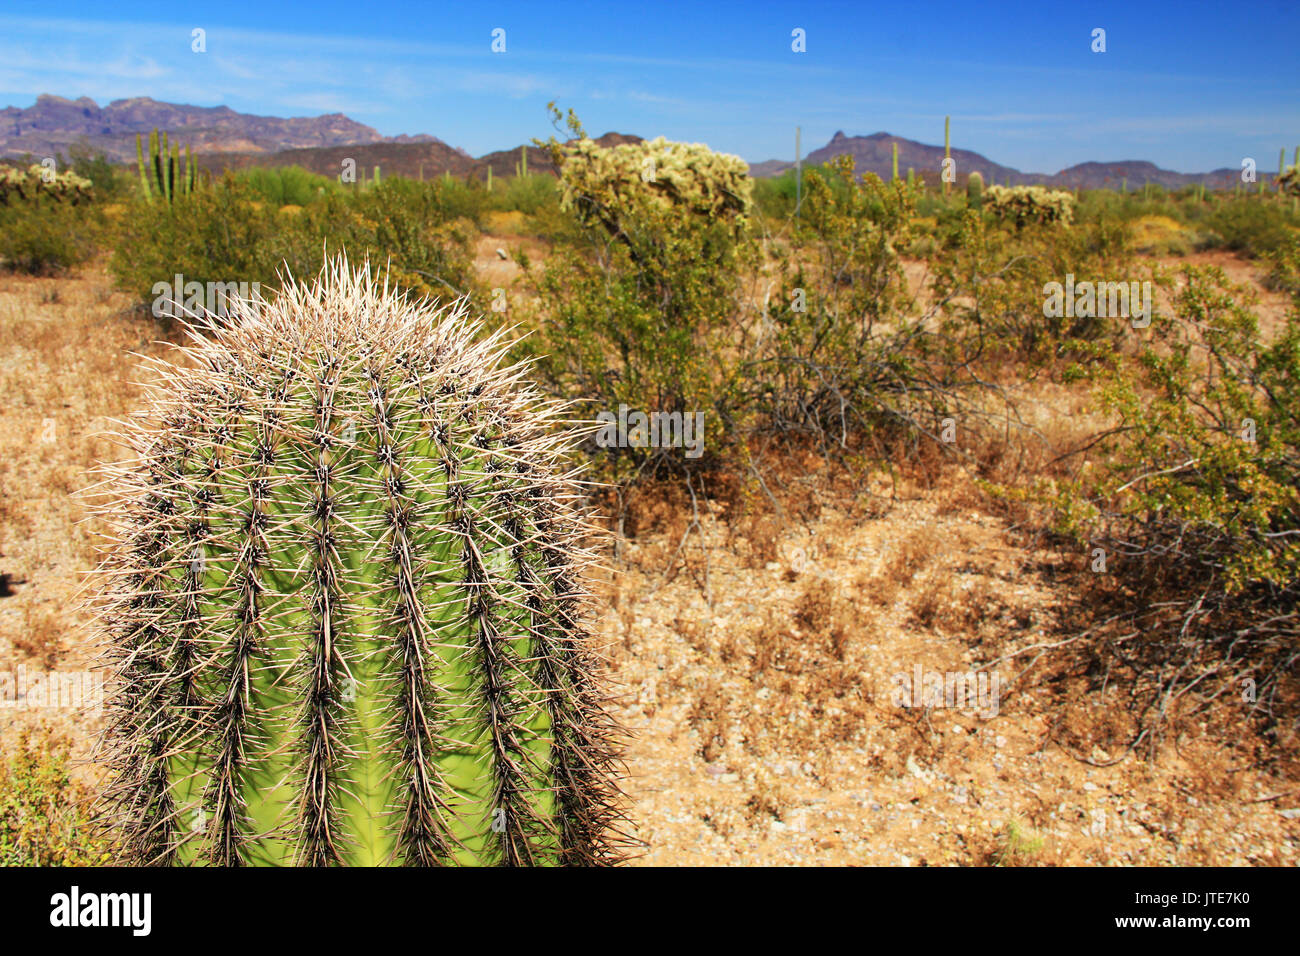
[525,114,750,477]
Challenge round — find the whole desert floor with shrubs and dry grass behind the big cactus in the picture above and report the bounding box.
[0,111,1300,865]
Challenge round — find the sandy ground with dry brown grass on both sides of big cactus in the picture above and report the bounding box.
[0,247,1300,865]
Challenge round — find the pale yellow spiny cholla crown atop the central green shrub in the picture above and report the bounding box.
[560,137,753,247]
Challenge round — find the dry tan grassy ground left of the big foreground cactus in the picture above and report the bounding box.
[0,260,169,756]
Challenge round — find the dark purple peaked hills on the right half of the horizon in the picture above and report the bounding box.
[749,131,1277,189]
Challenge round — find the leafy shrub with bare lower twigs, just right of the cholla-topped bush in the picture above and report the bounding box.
[742,157,943,445]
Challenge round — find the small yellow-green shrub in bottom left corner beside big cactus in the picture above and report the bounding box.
[0,728,111,866]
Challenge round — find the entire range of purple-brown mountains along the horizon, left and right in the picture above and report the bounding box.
[0,94,1273,189]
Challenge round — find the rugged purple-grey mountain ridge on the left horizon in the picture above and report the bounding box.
[0,94,465,163]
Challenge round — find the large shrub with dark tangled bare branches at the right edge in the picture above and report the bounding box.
[1058,267,1300,745]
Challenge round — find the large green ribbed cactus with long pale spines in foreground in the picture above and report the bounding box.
[86,259,625,865]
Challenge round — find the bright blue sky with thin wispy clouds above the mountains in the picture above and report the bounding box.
[0,0,1300,173]
